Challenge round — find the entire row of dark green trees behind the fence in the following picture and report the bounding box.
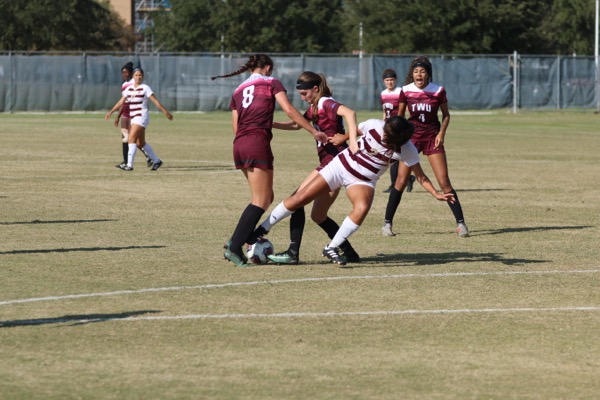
[0,0,596,55]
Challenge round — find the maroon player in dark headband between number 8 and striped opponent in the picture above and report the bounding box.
[269,71,360,264]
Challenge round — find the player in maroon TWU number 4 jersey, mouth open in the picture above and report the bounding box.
[381,56,469,237]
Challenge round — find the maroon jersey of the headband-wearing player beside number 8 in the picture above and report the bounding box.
[304,97,348,166]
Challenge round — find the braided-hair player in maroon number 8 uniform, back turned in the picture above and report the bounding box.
[212,54,327,267]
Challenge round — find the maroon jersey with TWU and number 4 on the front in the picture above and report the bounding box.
[400,83,448,142]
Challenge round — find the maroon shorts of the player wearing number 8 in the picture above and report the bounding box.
[233,135,274,169]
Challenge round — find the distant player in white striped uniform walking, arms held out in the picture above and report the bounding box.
[105,68,173,171]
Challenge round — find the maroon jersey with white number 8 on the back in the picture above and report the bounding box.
[229,74,286,142]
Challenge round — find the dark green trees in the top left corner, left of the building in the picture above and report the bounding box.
[0,0,133,51]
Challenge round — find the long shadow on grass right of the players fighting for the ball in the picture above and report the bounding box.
[348,252,547,268]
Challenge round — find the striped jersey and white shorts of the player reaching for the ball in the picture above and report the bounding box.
[319,119,419,191]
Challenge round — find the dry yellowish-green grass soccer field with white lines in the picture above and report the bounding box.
[0,111,600,400]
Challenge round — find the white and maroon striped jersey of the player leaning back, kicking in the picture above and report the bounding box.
[338,119,419,182]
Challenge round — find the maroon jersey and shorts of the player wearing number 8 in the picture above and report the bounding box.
[229,74,285,169]
